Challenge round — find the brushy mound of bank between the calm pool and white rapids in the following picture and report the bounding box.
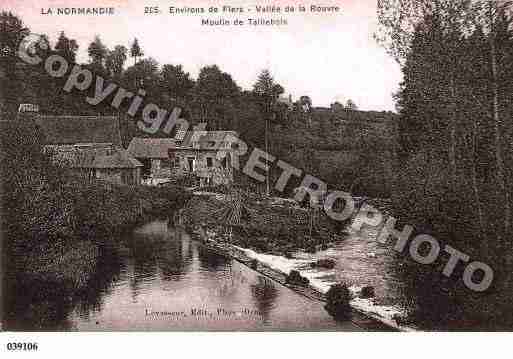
[181,192,343,257]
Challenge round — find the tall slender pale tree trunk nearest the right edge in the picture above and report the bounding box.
[489,2,511,239]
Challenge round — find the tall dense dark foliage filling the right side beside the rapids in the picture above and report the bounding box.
[378,0,513,325]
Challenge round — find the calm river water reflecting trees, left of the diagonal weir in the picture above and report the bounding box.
[3,221,359,331]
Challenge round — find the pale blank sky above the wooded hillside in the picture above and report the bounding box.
[1,0,401,111]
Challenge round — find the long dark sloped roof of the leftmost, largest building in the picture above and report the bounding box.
[36,116,121,146]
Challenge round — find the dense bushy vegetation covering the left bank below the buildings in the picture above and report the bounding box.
[0,121,187,300]
